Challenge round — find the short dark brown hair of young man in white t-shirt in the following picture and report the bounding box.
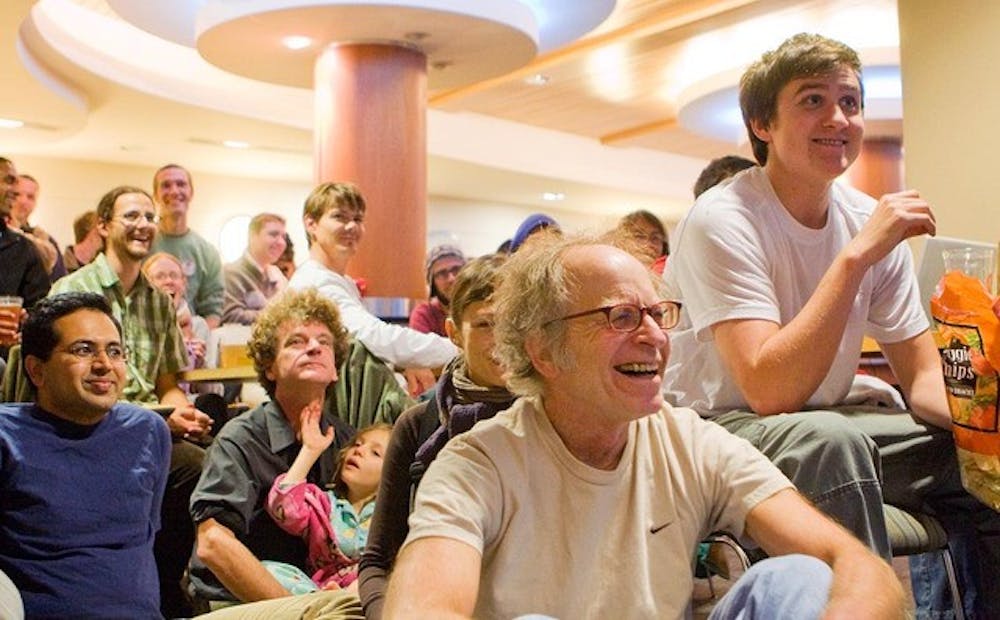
[740,33,865,166]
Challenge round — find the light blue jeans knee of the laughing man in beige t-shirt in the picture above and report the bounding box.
[709,555,833,620]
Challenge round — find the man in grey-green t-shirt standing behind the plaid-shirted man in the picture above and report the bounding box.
[153,164,225,329]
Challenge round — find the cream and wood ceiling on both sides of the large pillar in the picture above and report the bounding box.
[0,0,899,220]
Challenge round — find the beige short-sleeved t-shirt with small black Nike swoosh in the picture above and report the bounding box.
[404,399,792,619]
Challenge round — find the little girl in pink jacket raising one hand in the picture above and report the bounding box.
[264,418,392,594]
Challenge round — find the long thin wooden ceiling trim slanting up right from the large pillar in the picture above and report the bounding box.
[428,0,761,106]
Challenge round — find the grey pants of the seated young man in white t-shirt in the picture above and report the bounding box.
[713,407,1000,617]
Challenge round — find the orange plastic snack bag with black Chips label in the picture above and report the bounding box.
[931,271,1000,511]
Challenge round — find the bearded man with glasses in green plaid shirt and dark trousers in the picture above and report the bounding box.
[52,186,212,617]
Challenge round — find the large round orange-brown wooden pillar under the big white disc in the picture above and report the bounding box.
[314,43,427,299]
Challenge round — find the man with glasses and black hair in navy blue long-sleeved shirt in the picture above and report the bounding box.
[0,293,170,618]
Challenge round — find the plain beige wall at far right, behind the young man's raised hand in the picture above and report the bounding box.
[899,0,1000,243]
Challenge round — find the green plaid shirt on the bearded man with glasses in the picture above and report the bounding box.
[50,254,187,403]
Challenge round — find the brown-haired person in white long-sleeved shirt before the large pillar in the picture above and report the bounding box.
[288,183,457,396]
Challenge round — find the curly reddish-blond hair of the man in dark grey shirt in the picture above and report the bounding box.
[247,288,348,398]
